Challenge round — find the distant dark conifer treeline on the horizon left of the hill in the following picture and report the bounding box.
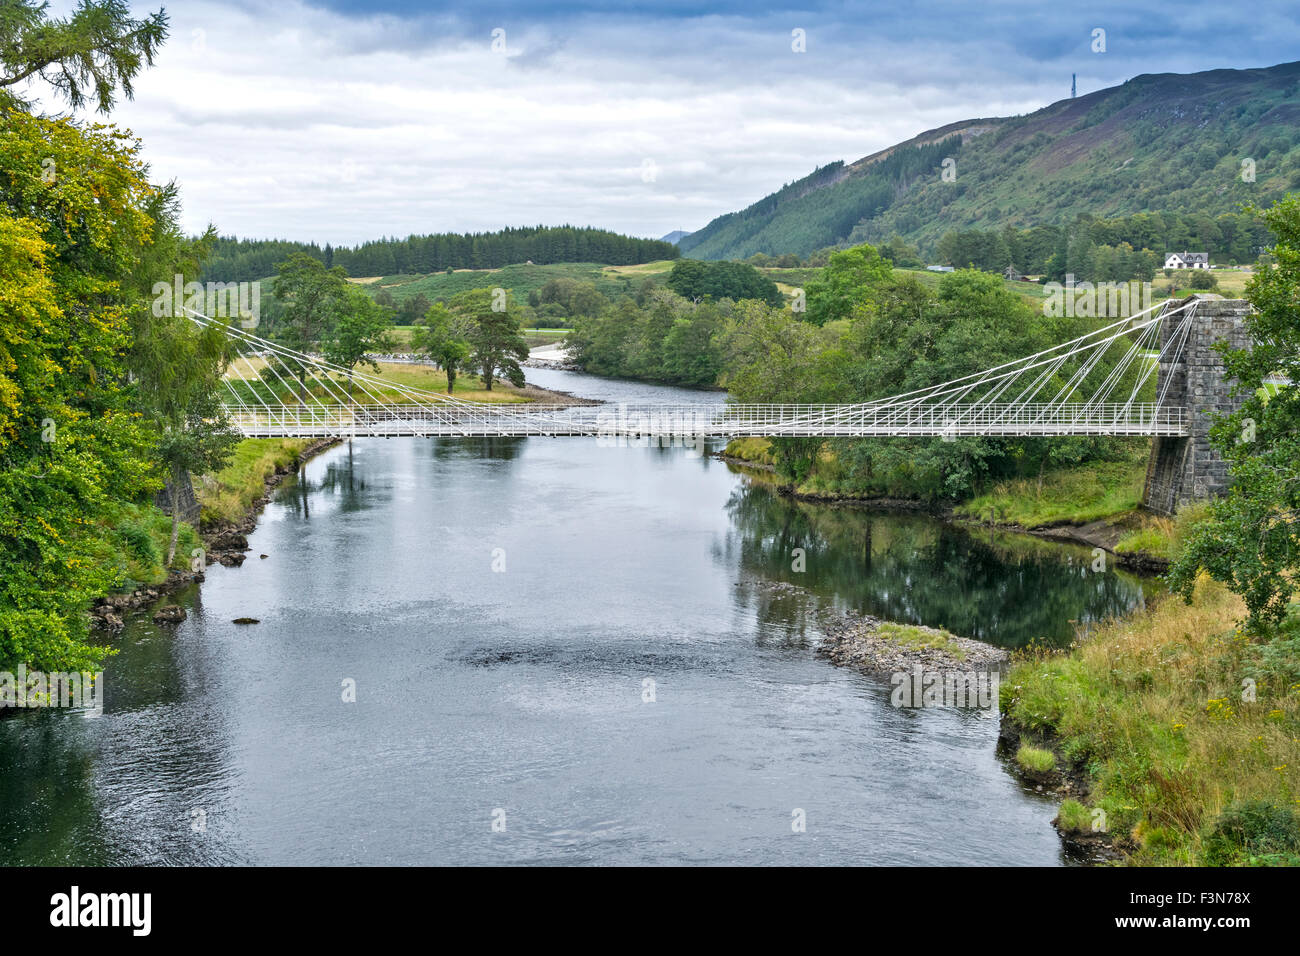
[203,226,680,282]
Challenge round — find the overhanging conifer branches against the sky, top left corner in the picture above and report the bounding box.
[0,0,168,113]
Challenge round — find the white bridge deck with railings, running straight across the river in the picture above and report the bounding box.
[226,403,1187,438]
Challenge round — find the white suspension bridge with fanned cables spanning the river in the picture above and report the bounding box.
[195,298,1203,438]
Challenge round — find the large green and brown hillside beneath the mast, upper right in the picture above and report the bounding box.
[679,62,1300,259]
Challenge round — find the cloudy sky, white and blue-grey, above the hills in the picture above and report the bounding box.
[38,0,1300,245]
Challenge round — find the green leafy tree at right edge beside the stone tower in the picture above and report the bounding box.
[1169,195,1300,631]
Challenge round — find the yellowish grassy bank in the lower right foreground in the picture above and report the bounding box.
[1002,580,1300,865]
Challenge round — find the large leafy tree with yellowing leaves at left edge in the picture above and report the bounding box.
[0,107,157,671]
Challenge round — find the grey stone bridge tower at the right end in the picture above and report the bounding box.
[1143,294,1251,515]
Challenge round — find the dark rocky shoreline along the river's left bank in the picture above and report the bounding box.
[90,438,342,633]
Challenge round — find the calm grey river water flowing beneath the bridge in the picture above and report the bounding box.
[0,369,1159,865]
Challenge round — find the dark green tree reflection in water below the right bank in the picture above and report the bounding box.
[728,484,1143,648]
